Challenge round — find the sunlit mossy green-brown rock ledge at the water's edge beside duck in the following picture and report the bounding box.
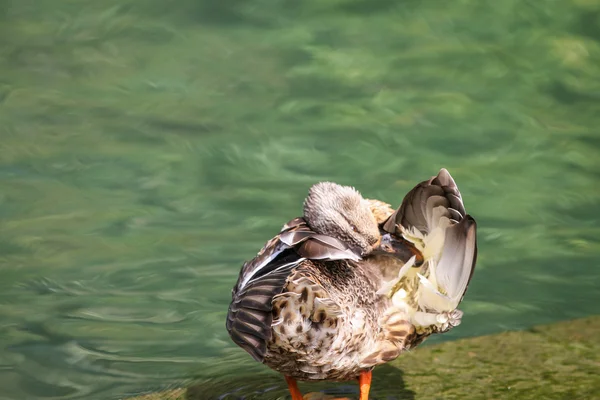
[123,317,600,400]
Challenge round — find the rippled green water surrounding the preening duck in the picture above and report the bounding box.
[0,0,600,400]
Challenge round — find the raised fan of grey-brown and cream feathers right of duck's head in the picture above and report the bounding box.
[383,169,477,312]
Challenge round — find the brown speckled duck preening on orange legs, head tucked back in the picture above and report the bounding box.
[227,169,476,400]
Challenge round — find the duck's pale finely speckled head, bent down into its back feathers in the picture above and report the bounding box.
[304,182,381,257]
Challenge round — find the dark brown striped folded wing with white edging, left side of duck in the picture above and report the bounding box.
[226,218,358,362]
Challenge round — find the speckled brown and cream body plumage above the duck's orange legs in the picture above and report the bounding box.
[264,257,413,380]
